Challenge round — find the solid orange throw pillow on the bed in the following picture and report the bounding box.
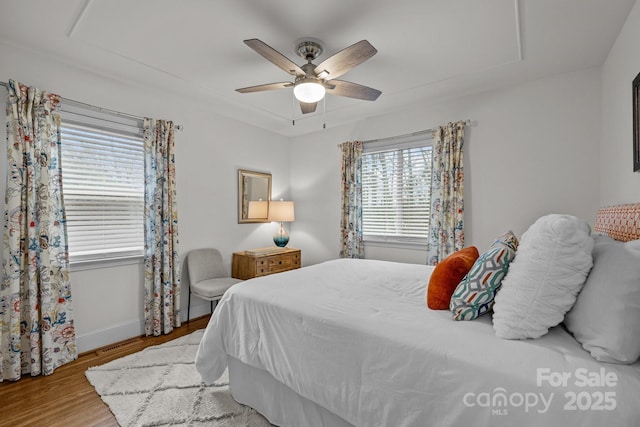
[427,246,480,310]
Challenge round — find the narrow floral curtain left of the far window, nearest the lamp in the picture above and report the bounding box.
[340,141,364,258]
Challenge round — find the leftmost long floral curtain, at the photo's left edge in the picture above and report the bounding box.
[0,80,77,381]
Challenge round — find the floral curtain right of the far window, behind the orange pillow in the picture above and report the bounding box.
[427,121,465,265]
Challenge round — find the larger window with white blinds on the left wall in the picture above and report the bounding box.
[61,101,144,263]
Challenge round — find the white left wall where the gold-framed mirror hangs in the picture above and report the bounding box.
[0,43,289,352]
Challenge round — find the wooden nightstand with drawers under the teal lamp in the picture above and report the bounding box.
[231,248,302,280]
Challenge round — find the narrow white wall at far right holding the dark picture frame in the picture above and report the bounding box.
[600,3,640,206]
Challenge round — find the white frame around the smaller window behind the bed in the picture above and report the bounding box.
[362,132,433,250]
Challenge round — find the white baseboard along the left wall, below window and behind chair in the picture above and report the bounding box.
[76,300,211,354]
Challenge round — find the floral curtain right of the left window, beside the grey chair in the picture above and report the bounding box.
[144,118,180,335]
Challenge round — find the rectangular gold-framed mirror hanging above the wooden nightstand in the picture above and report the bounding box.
[238,169,271,224]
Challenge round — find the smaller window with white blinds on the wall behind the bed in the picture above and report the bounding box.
[362,135,431,243]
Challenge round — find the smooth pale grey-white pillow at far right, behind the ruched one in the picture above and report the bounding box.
[564,236,640,363]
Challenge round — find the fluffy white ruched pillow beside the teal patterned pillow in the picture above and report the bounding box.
[493,214,593,339]
